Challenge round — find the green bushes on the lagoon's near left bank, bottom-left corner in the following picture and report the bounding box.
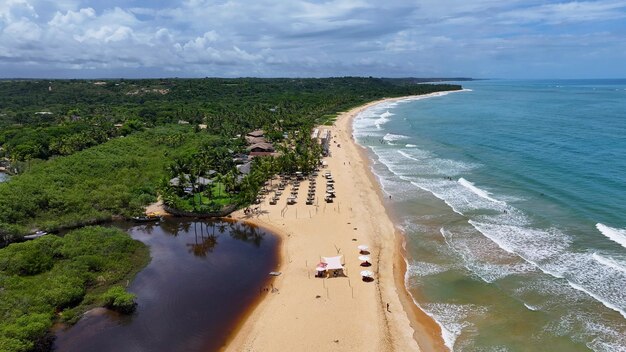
[0,227,149,352]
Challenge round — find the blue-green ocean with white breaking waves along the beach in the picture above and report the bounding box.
[353,80,626,352]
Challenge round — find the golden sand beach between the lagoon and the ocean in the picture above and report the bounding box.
[225,99,445,351]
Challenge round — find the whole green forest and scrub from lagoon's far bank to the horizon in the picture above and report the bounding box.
[0,77,460,244]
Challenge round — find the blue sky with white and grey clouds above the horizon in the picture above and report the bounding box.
[0,0,626,78]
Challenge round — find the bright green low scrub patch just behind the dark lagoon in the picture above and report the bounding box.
[0,126,213,242]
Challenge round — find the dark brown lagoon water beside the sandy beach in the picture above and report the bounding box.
[54,219,278,352]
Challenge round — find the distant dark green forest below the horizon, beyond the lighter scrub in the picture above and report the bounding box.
[0,77,460,160]
